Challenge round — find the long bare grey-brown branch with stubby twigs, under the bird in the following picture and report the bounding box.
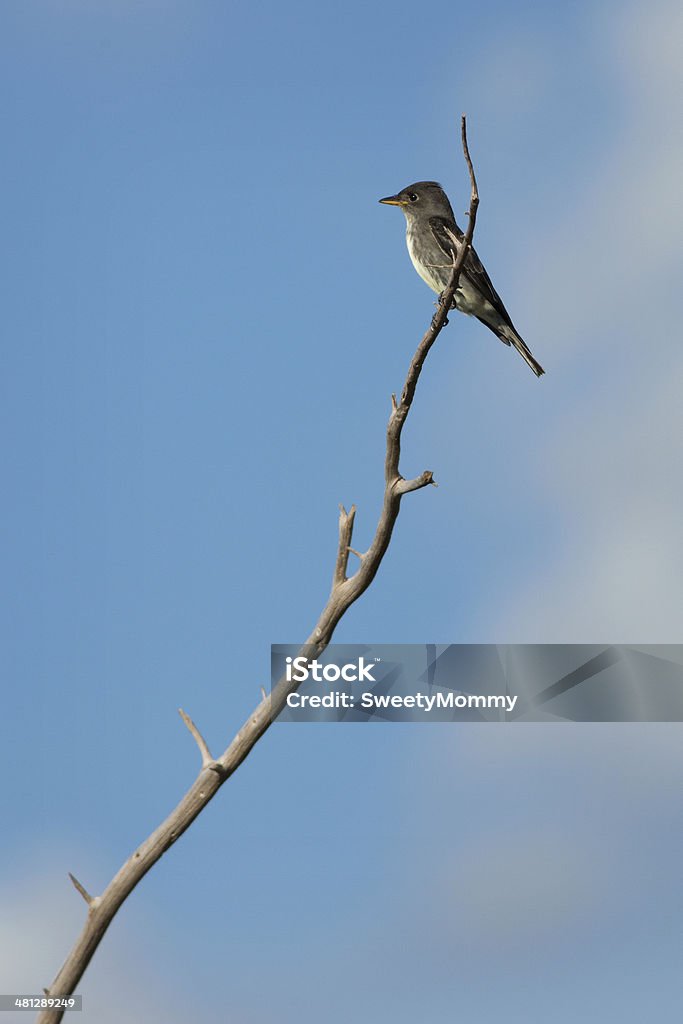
[38,116,479,1024]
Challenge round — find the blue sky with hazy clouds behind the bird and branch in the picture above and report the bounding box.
[0,0,683,1024]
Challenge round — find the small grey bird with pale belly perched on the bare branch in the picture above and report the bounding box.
[380,181,545,377]
